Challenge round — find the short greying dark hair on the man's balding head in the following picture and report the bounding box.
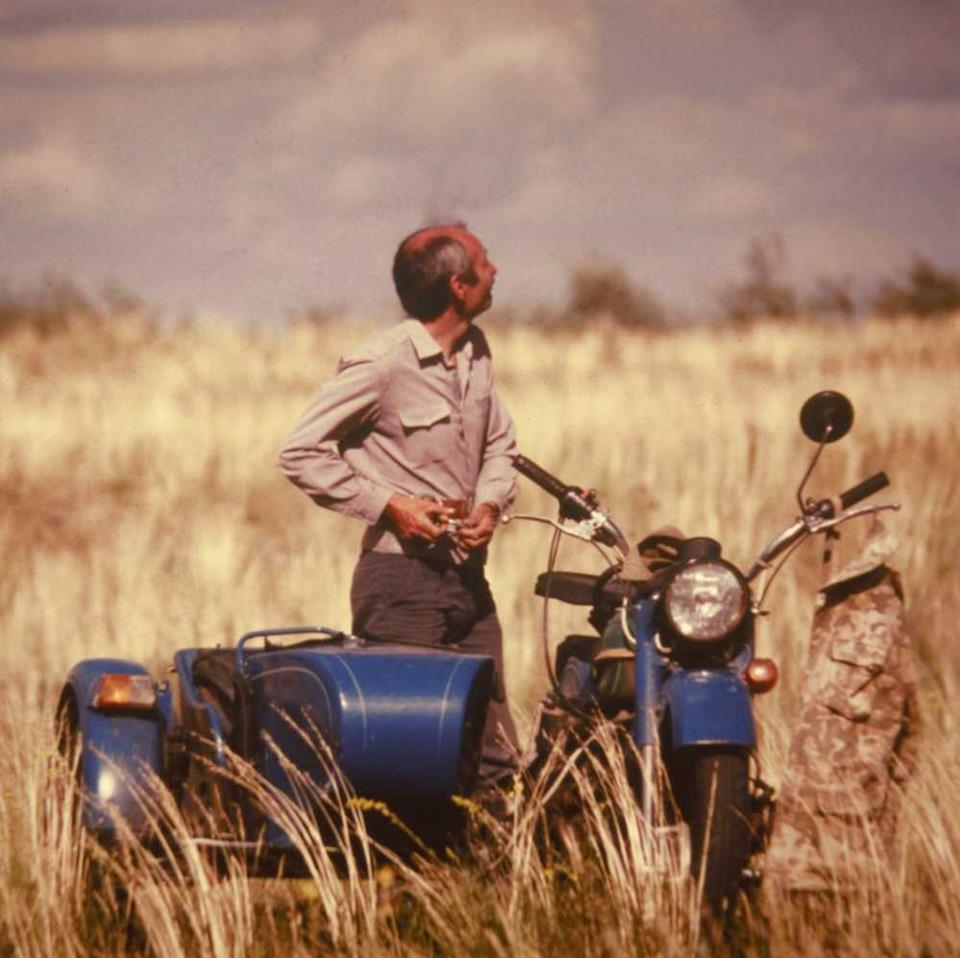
[393,223,473,320]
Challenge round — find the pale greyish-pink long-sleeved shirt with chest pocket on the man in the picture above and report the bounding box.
[279,319,517,562]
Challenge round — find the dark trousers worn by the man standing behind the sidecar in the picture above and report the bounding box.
[350,552,519,785]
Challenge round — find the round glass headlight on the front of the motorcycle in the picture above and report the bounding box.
[664,562,747,642]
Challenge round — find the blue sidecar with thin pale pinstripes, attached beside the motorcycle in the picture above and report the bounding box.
[58,626,493,852]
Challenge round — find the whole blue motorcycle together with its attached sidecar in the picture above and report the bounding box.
[57,393,893,907]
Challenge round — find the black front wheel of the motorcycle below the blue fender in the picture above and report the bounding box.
[671,747,750,914]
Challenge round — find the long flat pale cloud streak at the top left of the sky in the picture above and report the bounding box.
[0,16,320,78]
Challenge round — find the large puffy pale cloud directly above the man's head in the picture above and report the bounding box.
[221,0,597,251]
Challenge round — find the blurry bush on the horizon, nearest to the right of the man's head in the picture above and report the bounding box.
[561,261,667,329]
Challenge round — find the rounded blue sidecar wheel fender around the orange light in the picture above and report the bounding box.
[60,659,164,838]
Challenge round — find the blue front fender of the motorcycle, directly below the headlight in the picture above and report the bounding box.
[663,669,757,748]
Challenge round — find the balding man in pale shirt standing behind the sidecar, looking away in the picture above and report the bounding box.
[279,225,517,786]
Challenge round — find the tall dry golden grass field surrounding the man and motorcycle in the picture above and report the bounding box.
[0,317,960,955]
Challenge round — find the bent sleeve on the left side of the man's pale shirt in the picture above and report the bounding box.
[277,361,393,525]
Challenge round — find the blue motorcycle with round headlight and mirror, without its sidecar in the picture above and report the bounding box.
[506,391,898,912]
